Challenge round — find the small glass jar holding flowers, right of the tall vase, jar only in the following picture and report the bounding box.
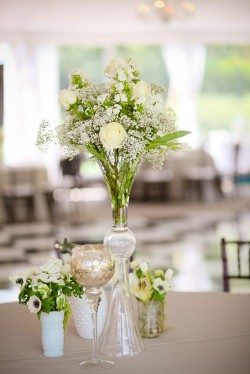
[138,300,165,338]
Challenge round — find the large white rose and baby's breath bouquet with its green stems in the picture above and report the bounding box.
[37,58,189,223]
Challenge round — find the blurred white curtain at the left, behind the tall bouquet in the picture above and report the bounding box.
[0,42,59,166]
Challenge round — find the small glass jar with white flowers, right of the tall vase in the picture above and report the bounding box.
[129,261,173,338]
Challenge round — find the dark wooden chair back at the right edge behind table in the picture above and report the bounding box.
[220,238,250,292]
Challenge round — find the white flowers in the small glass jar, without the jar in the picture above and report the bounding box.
[129,260,173,303]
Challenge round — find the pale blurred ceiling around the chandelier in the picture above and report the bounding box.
[0,0,250,46]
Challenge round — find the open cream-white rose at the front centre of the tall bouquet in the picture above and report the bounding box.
[99,122,127,150]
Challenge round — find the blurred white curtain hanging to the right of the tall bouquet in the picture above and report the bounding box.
[162,44,206,148]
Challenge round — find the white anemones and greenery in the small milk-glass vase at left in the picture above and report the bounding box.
[9,258,84,327]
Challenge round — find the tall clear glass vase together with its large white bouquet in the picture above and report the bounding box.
[37,58,189,357]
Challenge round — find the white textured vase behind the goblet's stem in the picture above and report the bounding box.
[70,290,108,339]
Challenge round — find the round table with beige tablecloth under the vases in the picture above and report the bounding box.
[0,292,250,374]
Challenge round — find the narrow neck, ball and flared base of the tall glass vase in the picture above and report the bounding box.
[101,206,144,357]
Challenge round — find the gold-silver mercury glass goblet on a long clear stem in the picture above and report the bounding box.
[71,244,115,370]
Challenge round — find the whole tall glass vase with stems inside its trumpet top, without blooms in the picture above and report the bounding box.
[99,157,144,357]
